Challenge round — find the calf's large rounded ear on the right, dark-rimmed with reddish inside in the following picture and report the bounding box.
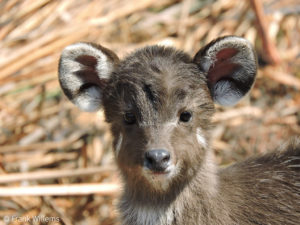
[194,36,257,106]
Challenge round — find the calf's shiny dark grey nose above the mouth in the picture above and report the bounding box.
[144,149,170,172]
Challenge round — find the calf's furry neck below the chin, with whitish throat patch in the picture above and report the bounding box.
[120,149,218,225]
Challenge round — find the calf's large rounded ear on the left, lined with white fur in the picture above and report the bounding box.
[58,43,119,112]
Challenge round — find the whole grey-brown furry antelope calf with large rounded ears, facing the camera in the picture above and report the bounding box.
[59,36,300,225]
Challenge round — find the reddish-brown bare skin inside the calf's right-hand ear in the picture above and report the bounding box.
[208,48,239,84]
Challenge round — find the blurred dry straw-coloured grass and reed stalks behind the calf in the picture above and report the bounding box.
[0,0,300,225]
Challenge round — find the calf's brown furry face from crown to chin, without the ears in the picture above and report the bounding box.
[103,46,214,190]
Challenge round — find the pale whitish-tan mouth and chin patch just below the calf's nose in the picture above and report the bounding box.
[142,165,178,191]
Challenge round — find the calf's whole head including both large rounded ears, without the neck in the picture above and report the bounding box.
[59,36,256,193]
